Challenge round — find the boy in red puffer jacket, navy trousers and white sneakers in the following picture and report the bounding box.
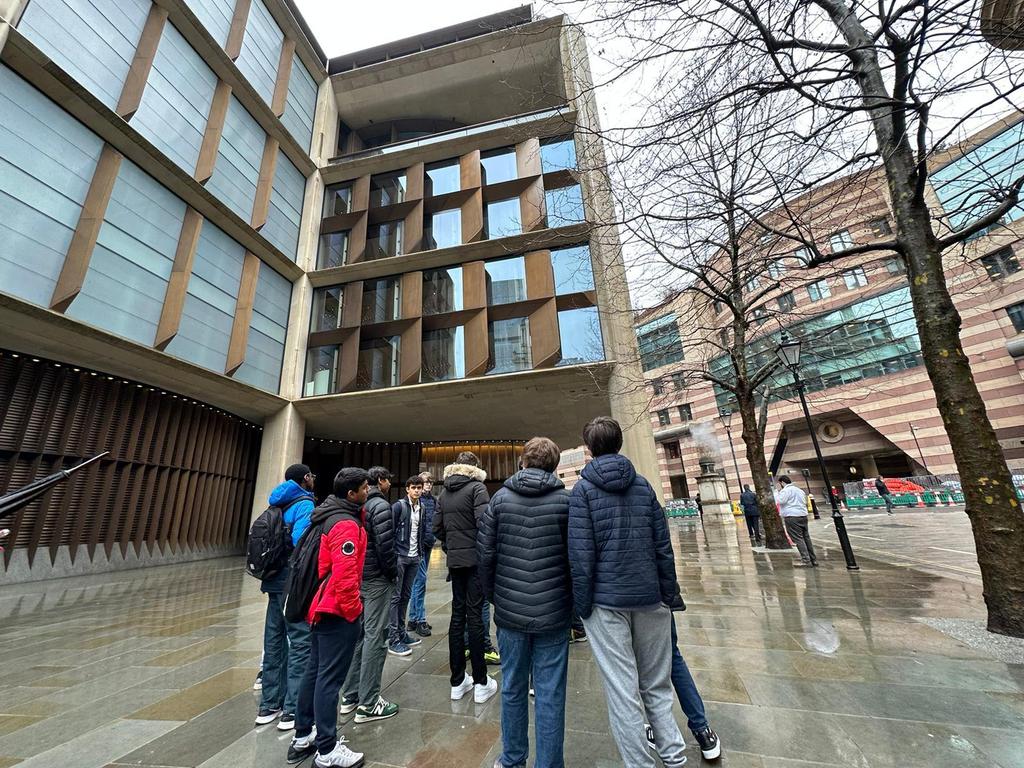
[288,467,370,768]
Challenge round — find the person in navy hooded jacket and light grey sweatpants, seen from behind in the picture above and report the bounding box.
[568,417,686,768]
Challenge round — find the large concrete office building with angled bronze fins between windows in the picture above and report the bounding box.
[0,0,655,580]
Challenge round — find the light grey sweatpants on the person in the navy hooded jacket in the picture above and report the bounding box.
[583,606,686,768]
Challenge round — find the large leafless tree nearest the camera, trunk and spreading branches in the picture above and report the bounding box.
[556,0,1024,636]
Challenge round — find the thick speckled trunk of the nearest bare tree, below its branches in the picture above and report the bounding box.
[894,217,1024,637]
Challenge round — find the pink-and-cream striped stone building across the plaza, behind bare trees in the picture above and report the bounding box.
[637,117,1024,498]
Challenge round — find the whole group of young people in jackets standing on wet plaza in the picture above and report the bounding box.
[251,417,721,768]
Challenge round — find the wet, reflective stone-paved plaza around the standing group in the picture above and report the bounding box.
[0,510,1024,768]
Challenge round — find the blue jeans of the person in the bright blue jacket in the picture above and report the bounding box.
[260,592,309,715]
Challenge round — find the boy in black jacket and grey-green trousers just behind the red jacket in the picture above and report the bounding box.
[341,467,398,723]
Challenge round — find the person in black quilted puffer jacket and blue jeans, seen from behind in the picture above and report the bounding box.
[477,437,572,768]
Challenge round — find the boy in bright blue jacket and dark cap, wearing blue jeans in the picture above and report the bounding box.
[256,464,316,731]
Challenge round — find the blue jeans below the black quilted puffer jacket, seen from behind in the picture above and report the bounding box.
[498,627,569,768]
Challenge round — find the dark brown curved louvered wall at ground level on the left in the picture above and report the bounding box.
[0,350,262,568]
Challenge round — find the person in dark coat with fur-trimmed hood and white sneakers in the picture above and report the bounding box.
[434,451,498,703]
